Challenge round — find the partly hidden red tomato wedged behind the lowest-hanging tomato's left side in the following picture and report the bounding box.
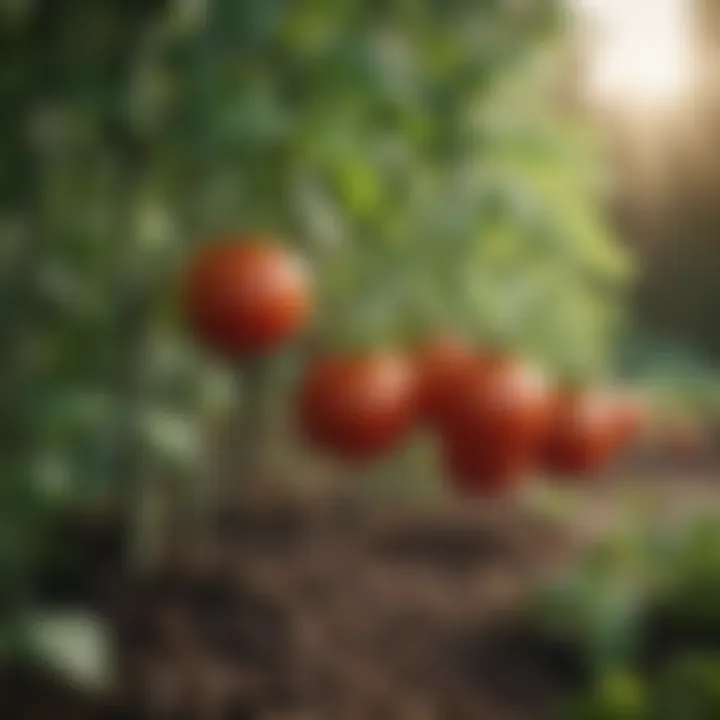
[415,335,474,428]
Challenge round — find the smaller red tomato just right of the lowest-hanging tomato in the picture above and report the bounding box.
[541,391,617,475]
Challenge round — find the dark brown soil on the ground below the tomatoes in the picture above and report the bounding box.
[118,492,583,720]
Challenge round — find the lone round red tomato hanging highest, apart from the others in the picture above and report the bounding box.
[184,239,312,357]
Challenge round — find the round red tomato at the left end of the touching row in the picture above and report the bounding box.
[298,353,416,458]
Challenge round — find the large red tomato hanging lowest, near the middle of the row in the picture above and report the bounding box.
[444,358,548,492]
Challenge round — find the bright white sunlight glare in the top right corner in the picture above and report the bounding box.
[577,0,691,106]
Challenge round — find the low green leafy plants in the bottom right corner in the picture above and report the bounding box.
[536,510,720,720]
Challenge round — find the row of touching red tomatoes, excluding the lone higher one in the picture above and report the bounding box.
[298,336,643,495]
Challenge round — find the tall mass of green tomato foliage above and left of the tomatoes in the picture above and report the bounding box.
[0,0,627,608]
